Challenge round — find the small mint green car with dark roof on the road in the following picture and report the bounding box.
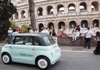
[1,33,61,70]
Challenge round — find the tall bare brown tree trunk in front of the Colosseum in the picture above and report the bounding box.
[28,0,36,30]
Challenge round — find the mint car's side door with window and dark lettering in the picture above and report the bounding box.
[11,36,35,64]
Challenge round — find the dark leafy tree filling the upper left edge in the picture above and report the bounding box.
[0,0,17,40]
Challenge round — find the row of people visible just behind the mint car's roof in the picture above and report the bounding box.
[8,27,57,42]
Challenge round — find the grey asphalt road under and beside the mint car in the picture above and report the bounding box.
[0,47,100,70]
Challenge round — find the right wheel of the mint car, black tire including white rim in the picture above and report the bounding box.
[36,57,51,70]
